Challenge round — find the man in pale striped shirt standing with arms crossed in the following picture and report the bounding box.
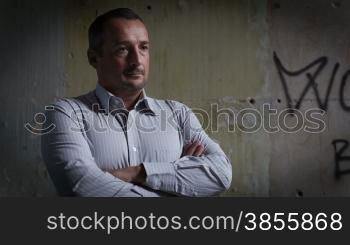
[42,8,232,197]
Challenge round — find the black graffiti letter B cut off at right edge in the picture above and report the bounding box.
[332,139,350,179]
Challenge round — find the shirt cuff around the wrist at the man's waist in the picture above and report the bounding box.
[142,162,176,192]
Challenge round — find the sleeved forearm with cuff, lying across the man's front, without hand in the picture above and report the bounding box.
[143,154,232,196]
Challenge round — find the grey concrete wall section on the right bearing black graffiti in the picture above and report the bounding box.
[265,0,350,196]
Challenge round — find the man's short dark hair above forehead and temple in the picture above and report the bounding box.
[89,8,143,51]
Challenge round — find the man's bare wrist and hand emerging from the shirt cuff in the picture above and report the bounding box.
[110,164,146,185]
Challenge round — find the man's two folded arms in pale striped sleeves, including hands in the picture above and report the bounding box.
[42,99,232,197]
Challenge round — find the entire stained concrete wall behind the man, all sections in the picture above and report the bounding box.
[0,0,350,196]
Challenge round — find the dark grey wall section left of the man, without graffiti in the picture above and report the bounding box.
[0,1,65,196]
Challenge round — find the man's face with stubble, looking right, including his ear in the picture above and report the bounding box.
[91,18,149,92]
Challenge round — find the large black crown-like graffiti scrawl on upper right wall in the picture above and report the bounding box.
[273,52,350,112]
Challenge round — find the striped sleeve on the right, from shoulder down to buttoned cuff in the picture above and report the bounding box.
[143,102,232,196]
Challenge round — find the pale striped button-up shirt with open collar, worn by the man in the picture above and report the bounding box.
[41,84,232,197]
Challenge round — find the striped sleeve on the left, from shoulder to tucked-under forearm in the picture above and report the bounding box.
[41,100,159,197]
